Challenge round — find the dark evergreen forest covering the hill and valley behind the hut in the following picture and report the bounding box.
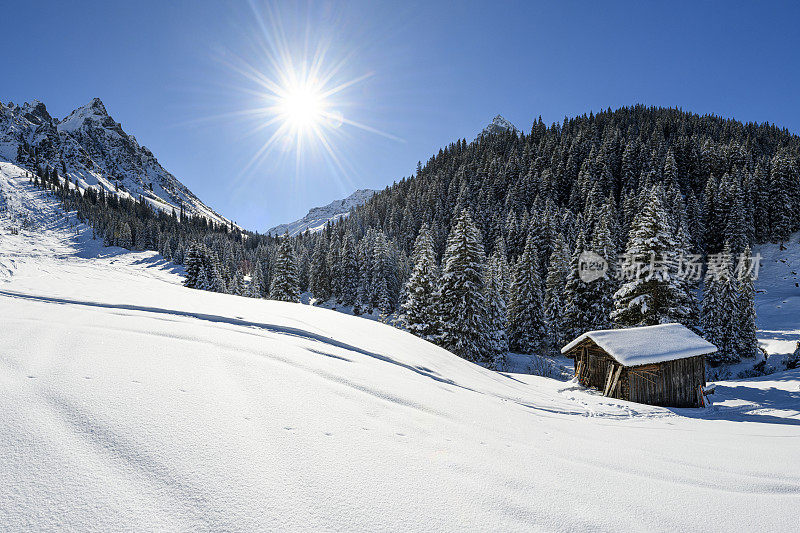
[25,106,800,366]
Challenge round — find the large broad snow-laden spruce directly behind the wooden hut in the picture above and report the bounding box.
[611,186,695,327]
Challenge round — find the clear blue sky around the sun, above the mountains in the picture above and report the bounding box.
[6,1,800,231]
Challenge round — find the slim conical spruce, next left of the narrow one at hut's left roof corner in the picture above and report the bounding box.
[508,236,547,353]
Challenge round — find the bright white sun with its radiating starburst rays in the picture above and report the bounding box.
[208,3,402,197]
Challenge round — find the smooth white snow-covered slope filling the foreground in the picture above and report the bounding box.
[0,164,800,532]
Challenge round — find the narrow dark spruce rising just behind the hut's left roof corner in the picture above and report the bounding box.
[544,233,570,352]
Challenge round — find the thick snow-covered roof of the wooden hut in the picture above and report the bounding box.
[561,324,717,366]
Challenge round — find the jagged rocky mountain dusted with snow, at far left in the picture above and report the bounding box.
[0,98,228,223]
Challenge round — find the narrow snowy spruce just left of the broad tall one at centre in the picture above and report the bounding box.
[402,225,440,342]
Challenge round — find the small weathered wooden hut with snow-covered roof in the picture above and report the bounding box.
[561,324,717,407]
